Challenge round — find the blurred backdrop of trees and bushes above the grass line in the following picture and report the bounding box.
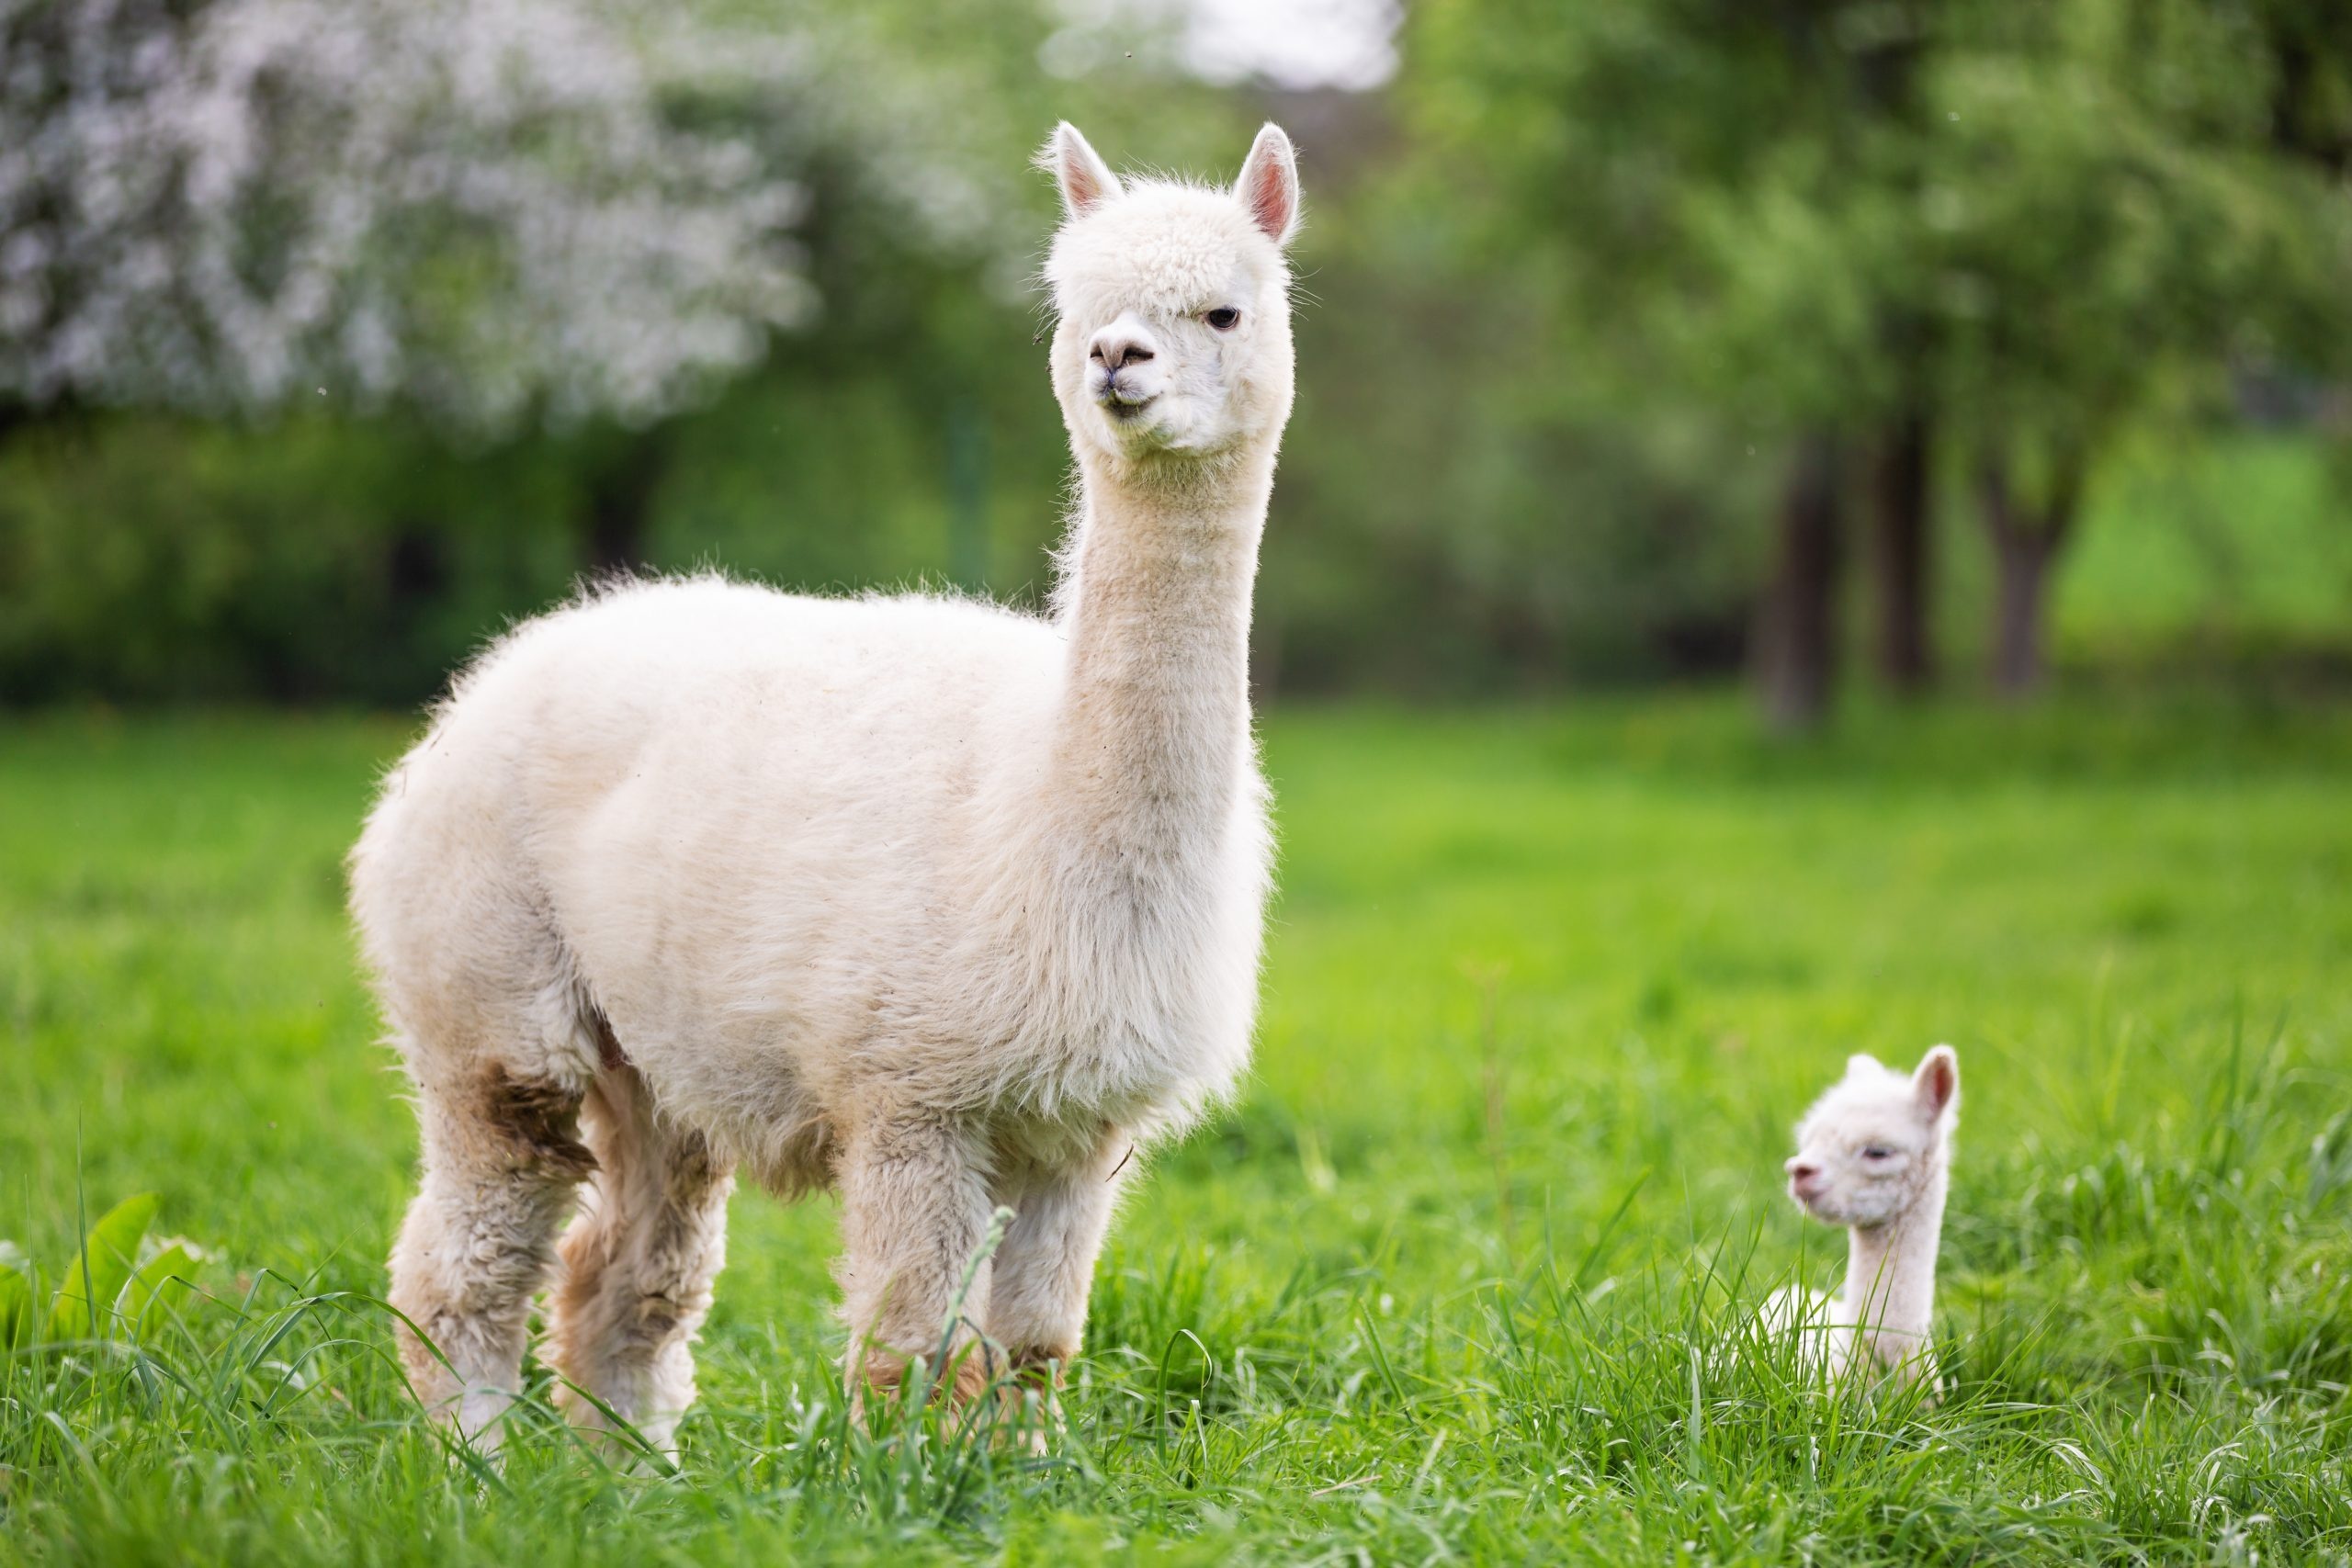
[0,0,2352,728]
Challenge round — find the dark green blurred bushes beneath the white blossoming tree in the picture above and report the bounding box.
[0,419,579,701]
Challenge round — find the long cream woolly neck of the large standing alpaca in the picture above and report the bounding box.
[1051,449,1275,861]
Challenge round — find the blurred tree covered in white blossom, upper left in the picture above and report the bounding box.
[0,0,809,434]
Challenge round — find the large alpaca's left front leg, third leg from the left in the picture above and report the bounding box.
[840,1117,990,1401]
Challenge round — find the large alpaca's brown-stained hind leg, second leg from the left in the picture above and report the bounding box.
[548,1065,734,1453]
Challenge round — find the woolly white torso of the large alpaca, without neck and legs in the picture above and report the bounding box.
[353,579,1270,1161]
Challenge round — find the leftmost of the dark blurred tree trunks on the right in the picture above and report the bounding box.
[1755,434,1844,731]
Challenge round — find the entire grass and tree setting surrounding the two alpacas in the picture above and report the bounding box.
[0,0,2352,1568]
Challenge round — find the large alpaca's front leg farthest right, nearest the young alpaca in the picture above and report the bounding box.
[986,1138,1129,1389]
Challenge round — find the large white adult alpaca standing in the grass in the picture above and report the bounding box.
[350,125,1298,1446]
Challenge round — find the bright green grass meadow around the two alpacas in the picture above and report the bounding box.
[0,698,2352,1568]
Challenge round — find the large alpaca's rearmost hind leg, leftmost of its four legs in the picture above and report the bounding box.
[390,1065,595,1450]
